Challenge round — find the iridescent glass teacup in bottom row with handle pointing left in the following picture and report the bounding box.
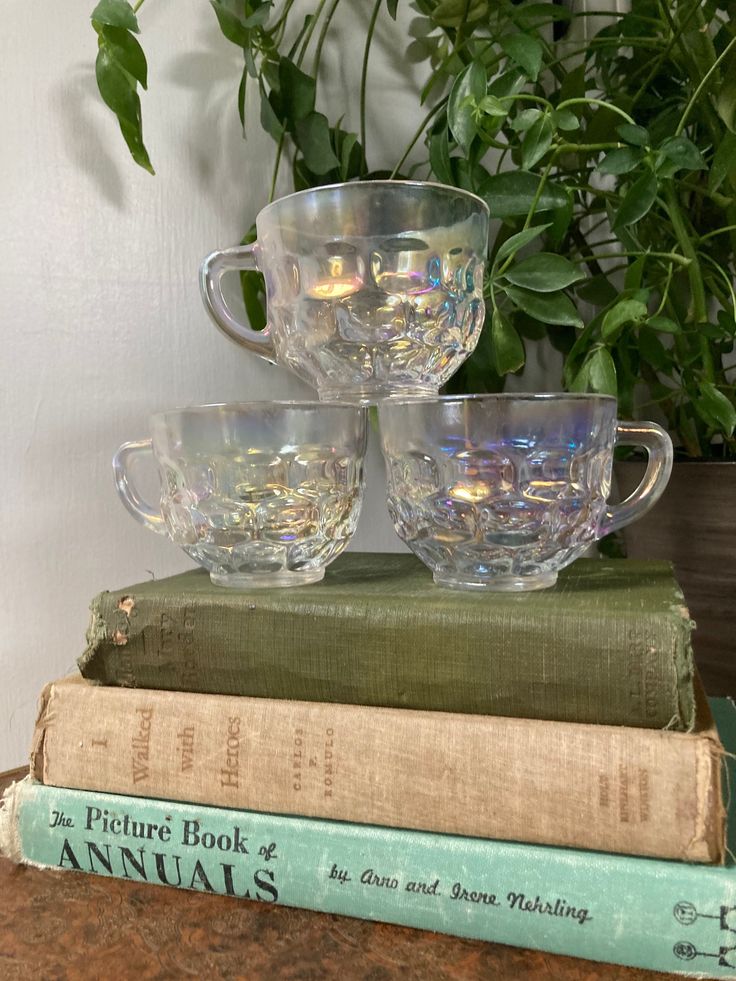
[113,402,367,588]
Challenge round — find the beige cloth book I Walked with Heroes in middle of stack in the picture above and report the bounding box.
[32,679,724,863]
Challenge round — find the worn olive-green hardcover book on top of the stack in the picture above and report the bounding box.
[79,552,694,730]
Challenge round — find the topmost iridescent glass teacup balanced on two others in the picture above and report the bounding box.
[200,181,488,404]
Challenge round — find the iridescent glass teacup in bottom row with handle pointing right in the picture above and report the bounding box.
[378,394,672,590]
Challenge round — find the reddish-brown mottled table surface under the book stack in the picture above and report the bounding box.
[0,770,675,981]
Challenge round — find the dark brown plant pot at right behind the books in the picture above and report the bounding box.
[615,460,736,695]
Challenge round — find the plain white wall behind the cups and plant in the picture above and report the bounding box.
[0,0,426,770]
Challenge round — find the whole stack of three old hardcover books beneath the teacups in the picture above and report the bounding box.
[0,553,736,977]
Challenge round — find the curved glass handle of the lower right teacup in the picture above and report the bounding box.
[598,422,672,538]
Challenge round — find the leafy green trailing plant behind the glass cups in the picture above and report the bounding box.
[92,0,736,458]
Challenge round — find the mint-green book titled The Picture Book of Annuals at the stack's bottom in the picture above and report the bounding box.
[5,701,736,978]
